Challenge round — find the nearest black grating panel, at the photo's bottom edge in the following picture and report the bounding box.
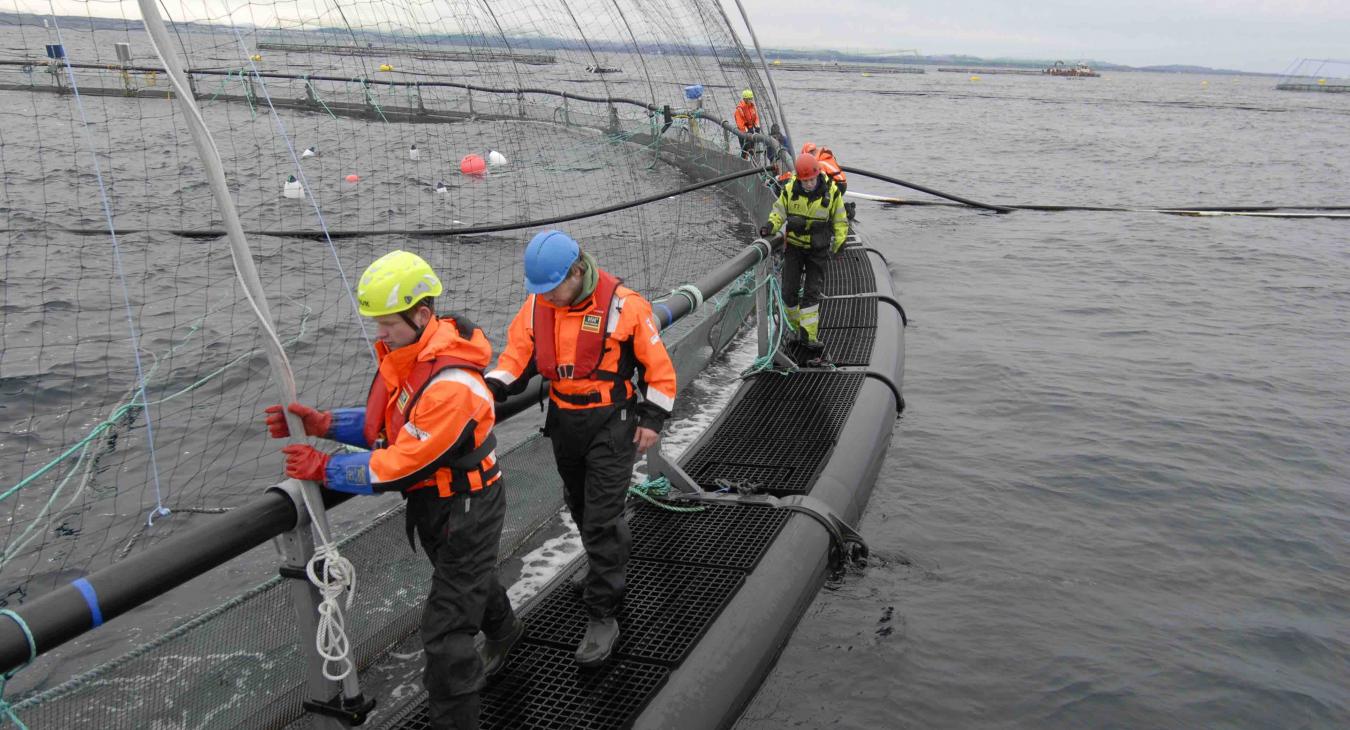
[388,642,670,730]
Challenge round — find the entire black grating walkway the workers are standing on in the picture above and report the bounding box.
[387,248,876,730]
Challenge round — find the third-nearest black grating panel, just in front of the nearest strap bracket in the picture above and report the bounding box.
[628,502,790,571]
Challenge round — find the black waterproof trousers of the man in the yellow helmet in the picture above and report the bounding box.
[408,478,512,730]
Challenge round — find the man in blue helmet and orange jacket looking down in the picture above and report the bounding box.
[487,231,675,667]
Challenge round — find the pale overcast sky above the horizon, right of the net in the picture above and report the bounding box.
[724,0,1350,73]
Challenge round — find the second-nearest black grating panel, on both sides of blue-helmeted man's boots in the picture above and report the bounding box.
[522,560,745,665]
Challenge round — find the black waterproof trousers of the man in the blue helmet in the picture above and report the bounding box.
[545,401,637,618]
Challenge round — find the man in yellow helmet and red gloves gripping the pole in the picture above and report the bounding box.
[266,251,525,730]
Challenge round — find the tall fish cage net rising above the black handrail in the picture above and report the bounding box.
[0,0,778,717]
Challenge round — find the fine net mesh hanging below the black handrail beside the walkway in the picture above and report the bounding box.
[16,286,753,730]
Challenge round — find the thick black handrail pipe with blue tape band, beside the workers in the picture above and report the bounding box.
[0,240,771,672]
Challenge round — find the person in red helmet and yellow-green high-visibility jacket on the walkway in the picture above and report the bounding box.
[760,152,848,366]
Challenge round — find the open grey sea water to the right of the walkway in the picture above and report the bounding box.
[737,73,1350,730]
